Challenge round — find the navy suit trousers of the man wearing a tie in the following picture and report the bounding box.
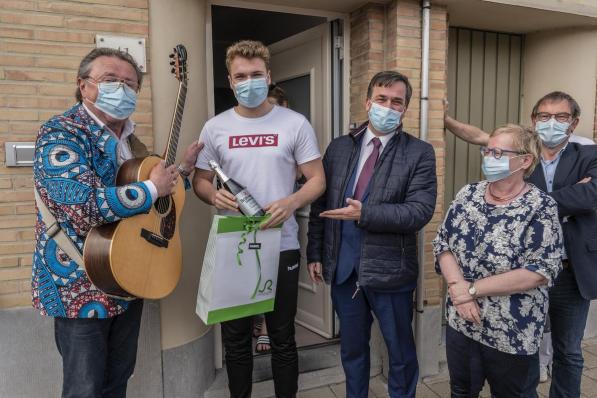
[332,272,419,398]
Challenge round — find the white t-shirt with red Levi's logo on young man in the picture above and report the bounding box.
[195,105,321,251]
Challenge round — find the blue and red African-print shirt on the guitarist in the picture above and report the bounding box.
[31,104,152,318]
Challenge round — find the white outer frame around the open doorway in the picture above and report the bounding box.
[205,0,350,369]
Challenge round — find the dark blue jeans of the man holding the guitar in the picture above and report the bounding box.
[54,300,143,398]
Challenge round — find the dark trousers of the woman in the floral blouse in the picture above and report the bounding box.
[446,326,539,398]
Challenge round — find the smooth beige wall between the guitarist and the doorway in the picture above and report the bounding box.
[149,0,211,349]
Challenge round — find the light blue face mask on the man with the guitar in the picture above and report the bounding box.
[88,80,137,120]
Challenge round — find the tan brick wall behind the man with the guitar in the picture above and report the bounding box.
[0,0,153,308]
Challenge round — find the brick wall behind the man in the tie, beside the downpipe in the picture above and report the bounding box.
[350,0,448,304]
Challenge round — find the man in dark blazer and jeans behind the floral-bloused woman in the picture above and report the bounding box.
[528,91,597,398]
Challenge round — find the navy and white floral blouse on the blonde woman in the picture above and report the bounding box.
[433,181,563,355]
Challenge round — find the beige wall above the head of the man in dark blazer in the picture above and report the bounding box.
[520,29,597,137]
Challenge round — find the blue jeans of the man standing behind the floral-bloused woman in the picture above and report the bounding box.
[549,268,590,398]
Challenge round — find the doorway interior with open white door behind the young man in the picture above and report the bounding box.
[208,5,342,348]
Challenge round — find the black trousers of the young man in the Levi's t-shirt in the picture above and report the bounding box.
[222,250,300,398]
